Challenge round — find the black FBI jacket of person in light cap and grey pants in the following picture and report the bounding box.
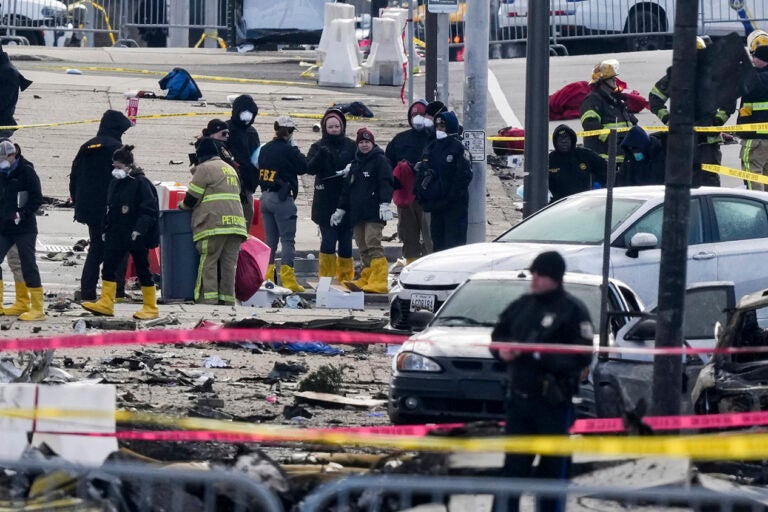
[259,139,307,199]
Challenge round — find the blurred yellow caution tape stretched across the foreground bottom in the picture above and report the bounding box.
[10,409,768,460]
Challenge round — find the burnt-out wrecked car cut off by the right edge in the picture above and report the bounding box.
[691,290,768,414]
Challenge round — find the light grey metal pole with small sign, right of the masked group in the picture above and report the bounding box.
[464,0,490,243]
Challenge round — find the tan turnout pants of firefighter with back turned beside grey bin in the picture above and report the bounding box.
[195,235,243,304]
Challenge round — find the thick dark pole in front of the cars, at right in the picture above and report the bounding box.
[651,0,699,416]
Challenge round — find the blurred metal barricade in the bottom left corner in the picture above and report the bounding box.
[0,460,285,512]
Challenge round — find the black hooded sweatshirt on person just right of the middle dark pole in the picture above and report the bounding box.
[549,124,607,201]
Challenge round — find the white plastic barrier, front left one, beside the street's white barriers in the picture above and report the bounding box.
[317,19,363,87]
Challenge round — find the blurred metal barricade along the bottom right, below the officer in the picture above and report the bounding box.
[300,475,763,512]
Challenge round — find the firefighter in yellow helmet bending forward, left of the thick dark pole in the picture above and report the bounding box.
[580,59,637,165]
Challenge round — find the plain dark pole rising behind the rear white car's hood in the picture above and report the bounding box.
[523,0,550,217]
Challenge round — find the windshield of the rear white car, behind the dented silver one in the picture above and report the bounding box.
[496,196,643,245]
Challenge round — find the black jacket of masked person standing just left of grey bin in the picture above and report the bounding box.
[104,168,160,250]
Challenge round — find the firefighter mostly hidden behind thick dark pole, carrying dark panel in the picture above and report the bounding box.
[648,37,736,187]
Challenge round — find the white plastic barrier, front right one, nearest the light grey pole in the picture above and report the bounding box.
[363,17,406,85]
